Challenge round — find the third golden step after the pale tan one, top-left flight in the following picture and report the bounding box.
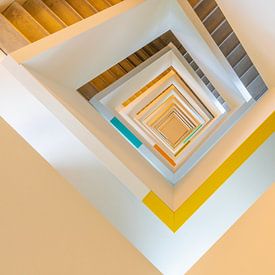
[43,0,82,26]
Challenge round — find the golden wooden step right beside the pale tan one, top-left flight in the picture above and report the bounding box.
[3,2,49,42]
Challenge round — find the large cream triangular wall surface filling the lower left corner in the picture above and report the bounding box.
[0,119,159,275]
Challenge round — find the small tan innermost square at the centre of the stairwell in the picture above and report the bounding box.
[158,113,190,147]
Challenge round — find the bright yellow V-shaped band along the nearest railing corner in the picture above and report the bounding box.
[143,112,275,232]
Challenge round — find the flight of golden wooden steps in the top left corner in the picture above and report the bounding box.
[0,0,123,53]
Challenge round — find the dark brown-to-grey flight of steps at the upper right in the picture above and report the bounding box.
[188,0,267,100]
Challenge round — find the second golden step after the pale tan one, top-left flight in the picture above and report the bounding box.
[23,0,66,33]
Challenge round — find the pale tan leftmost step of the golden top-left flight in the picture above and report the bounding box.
[0,14,30,53]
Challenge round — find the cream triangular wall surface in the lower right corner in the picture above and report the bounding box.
[187,184,275,275]
